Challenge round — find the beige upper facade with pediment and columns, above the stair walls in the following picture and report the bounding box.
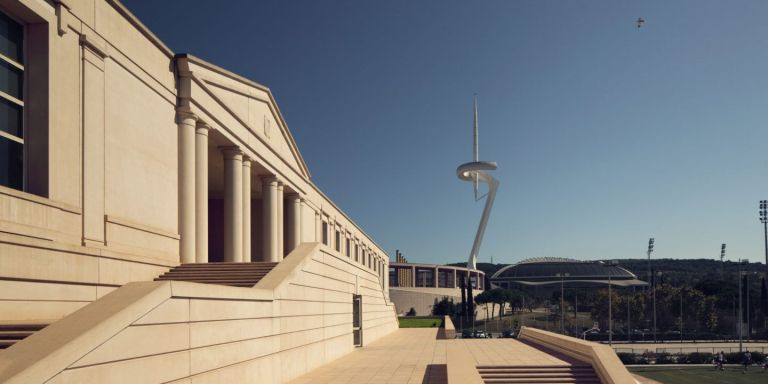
[0,0,388,320]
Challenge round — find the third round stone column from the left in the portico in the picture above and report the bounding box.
[222,147,243,262]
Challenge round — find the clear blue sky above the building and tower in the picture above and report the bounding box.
[124,0,768,263]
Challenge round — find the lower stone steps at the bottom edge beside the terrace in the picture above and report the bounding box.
[477,365,600,384]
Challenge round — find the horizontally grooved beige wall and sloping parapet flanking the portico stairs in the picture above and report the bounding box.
[0,244,397,384]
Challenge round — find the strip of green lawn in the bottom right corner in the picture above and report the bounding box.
[629,366,768,384]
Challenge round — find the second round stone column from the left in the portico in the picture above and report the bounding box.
[195,121,211,263]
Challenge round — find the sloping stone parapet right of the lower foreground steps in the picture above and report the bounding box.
[518,327,635,384]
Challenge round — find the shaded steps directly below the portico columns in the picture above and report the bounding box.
[155,262,277,287]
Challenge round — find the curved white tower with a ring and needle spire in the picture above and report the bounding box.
[456,96,499,269]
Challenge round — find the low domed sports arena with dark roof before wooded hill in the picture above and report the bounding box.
[490,257,648,288]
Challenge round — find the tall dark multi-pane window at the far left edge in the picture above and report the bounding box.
[0,12,24,190]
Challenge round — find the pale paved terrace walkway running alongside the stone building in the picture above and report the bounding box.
[291,328,584,384]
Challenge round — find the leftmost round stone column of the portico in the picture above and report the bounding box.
[177,111,197,263]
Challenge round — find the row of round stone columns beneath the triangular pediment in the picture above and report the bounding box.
[177,111,304,263]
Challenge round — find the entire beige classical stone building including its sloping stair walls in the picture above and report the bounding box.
[0,0,397,383]
